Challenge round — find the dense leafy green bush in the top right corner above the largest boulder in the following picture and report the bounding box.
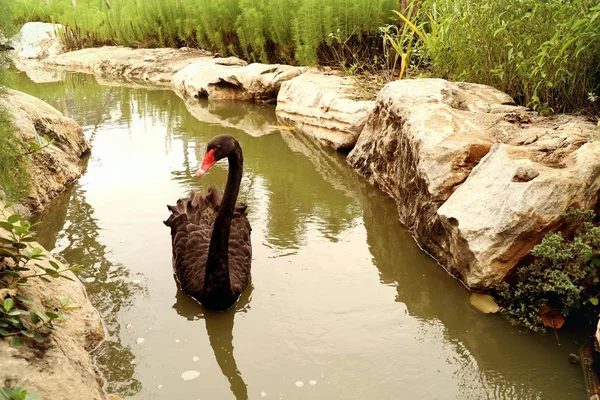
[421,0,600,112]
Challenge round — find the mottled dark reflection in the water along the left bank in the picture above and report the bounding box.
[31,185,141,396]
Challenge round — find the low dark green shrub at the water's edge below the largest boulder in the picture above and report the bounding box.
[497,210,600,331]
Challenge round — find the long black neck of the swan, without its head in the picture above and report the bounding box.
[204,142,244,295]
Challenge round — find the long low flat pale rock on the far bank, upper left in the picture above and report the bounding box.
[44,46,212,87]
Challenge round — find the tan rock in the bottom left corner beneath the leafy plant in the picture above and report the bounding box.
[0,211,105,400]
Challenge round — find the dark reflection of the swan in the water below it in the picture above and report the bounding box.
[173,281,253,400]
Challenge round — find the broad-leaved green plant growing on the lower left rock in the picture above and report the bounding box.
[0,208,81,348]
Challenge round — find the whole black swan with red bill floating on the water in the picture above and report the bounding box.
[164,135,252,311]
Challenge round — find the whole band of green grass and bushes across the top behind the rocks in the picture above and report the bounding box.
[5,0,600,114]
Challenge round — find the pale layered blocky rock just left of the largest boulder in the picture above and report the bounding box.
[276,71,375,149]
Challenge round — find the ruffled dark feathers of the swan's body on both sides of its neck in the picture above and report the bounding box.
[164,185,252,300]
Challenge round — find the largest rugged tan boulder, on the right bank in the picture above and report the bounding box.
[348,79,600,290]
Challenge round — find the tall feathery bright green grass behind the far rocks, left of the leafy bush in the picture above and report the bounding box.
[14,0,398,64]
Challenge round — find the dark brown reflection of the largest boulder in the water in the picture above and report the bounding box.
[359,185,568,399]
